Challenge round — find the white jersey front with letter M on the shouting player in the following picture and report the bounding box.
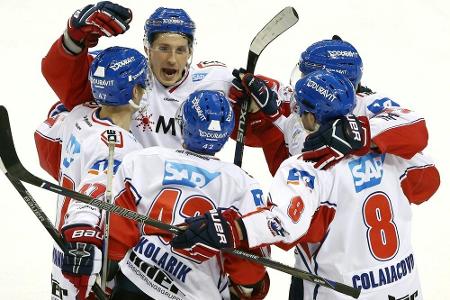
[131,61,233,149]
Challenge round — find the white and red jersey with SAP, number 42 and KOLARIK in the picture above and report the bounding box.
[110,147,265,299]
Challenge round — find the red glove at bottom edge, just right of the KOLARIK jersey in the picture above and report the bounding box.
[230,272,270,300]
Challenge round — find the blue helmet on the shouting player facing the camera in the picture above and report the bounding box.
[144,7,195,43]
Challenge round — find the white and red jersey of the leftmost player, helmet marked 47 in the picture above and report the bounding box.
[35,104,142,299]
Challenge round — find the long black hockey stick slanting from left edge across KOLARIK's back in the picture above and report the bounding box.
[0,105,360,298]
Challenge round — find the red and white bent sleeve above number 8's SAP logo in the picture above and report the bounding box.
[369,107,428,159]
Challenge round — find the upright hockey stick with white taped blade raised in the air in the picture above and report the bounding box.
[234,6,298,167]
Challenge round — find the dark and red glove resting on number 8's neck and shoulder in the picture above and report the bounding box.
[302,115,370,169]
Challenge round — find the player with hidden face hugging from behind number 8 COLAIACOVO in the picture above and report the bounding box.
[230,36,428,299]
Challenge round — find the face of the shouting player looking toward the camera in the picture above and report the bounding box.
[148,33,191,86]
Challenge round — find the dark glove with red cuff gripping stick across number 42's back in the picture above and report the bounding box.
[171,209,240,258]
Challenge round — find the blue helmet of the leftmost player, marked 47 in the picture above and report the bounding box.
[89,47,148,106]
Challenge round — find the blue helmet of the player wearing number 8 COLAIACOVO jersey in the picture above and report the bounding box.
[295,70,356,124]
